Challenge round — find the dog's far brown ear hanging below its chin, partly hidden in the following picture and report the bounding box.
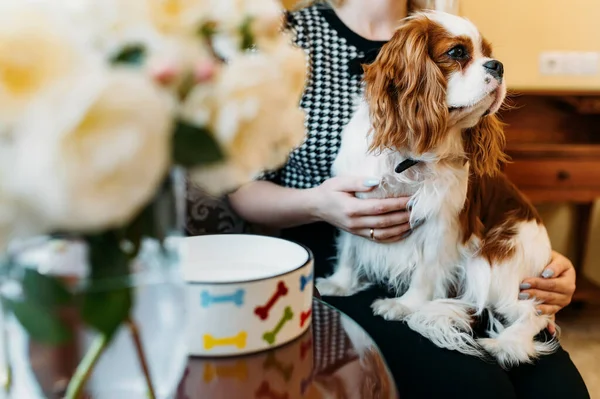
[463,115,509,176]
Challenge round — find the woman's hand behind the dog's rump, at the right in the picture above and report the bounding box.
[519,251,575,334]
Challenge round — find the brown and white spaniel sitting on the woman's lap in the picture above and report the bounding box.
[317,12,557,367]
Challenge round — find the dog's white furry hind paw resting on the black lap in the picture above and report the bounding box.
[477,338,536,370]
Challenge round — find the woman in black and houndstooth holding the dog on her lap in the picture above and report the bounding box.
[230,0,589,399]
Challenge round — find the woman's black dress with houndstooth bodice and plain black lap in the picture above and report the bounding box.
[263,6,589,399]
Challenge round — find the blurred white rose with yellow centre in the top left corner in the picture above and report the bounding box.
[0,0,100,135]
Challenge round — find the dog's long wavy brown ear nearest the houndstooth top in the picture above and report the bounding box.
[364,17,448,153]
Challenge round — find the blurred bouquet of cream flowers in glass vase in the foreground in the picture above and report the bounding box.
[0,0,306,398]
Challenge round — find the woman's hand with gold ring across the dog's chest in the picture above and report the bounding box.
[312,176,417,243]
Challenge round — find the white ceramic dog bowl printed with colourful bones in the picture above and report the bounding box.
[181,234,313,356]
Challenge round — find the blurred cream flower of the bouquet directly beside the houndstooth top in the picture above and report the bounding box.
[183,37,306,193]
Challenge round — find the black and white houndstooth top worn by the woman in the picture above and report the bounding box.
[261,5,384,188]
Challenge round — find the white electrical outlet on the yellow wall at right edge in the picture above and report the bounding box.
[539,51,600,76]
